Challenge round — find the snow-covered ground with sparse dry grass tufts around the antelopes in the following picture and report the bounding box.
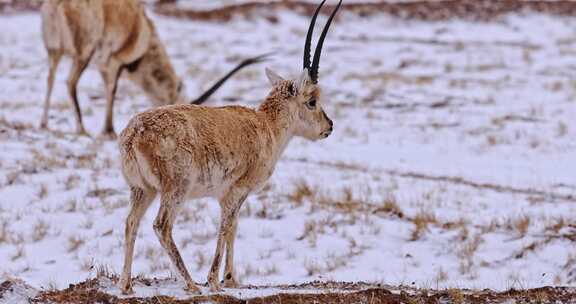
[0,3,576,296]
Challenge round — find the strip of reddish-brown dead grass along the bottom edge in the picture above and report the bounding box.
[11,278,576,304]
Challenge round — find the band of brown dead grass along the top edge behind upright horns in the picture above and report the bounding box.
[156,0,576,22]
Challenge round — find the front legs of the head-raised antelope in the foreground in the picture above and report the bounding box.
[208,191,248,292]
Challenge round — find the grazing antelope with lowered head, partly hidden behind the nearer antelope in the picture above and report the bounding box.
[40,0,262,138]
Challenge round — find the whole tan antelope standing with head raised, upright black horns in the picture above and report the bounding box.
[119,1,341,294]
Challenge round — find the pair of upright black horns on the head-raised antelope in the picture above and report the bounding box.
[304,0,342,83]
